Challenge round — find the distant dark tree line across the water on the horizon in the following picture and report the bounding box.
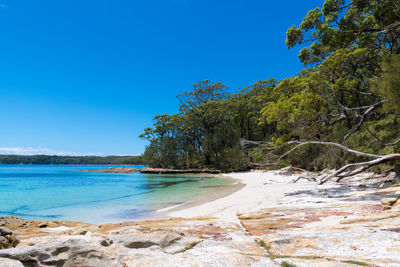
[0,155,147,165]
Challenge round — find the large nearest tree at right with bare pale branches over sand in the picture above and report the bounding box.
[248,0,400,183]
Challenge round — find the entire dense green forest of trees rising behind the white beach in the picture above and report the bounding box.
[141,0,400,176]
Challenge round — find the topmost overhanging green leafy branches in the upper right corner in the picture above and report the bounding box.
[286,0,400,64]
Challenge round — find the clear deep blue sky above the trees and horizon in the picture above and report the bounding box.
[0,0,323,155]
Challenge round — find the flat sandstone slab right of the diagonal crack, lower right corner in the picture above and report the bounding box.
[238,191,400,267]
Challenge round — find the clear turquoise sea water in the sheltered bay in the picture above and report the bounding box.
[0,165,232,223]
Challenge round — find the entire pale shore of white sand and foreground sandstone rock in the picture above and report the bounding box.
[0,170,400,267]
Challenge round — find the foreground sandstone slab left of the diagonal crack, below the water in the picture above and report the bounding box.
[0,218,276,267]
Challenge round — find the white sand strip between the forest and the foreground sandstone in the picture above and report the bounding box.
[168,170,400,222]
